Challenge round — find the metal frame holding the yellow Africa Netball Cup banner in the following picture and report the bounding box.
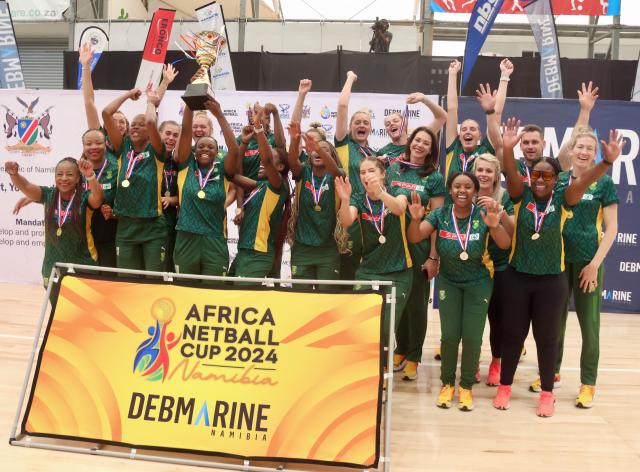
[9,263,396,472]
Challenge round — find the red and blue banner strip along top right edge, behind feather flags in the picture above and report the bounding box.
[431,0,620,16]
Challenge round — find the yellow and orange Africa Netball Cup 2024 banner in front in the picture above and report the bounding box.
[22,276,382,467]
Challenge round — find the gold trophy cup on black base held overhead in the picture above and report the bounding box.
[180,31,226,110]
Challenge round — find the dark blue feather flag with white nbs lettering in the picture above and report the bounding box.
[460,0,504,90]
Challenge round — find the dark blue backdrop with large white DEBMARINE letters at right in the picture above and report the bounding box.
[452,98,640,313]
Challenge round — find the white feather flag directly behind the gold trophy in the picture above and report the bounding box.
[196,2,236,90]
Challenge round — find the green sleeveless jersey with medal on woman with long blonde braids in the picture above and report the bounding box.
[295,164,336,247]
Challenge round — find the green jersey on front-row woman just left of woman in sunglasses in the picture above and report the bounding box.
[425,203,493,284]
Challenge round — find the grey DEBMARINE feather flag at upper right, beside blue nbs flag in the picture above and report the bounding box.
[524,0,562,98]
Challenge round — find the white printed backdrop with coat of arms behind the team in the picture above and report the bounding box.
[0,90,438,283]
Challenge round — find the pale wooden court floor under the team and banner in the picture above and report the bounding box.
[0,284,640,472]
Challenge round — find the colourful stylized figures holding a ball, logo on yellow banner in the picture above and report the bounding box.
[133,298,180,382]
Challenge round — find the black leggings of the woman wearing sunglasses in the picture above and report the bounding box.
[500,267,569,392]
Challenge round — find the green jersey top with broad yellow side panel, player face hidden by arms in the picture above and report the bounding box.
[238,179,289,252]
